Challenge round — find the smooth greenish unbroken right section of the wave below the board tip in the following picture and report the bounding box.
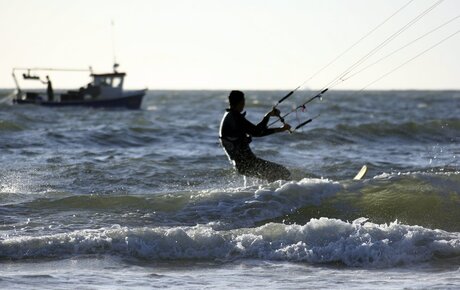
[272,172,460,231]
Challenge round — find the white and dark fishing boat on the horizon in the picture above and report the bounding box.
[13,63,146,109]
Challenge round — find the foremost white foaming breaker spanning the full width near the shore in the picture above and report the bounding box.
[0,218,460,267]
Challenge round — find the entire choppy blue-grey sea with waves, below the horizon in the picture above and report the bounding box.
[0,90,460,289]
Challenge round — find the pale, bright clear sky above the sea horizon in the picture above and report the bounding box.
[0,0,460,90]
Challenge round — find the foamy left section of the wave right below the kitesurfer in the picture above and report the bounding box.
[15,179,343,229]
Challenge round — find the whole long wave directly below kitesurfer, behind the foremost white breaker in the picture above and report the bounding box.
[9,172,460,231]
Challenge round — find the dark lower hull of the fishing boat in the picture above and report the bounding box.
[13,90,145,110]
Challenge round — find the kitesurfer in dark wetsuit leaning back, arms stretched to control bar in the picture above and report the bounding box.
[219,91,291,182]
